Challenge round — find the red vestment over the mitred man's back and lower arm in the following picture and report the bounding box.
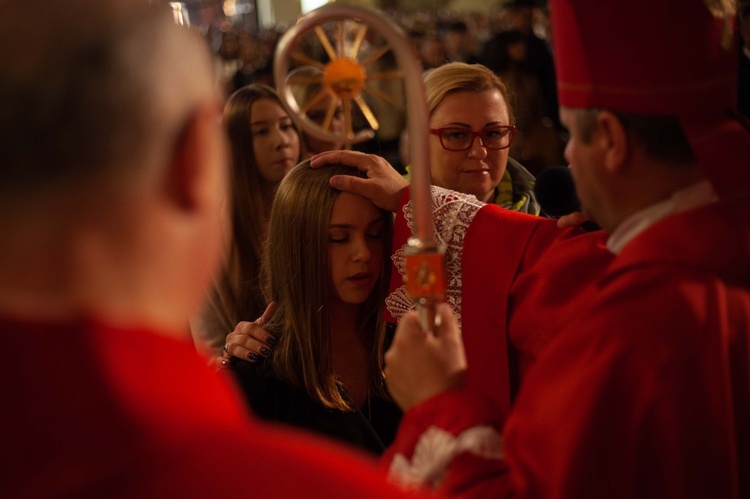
[387,197,750,498]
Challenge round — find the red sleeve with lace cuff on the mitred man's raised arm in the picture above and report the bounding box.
[387,187,612,415]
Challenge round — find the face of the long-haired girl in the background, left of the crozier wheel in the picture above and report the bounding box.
[250,99,300,184]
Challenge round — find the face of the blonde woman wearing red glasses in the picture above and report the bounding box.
[430,89,510,202]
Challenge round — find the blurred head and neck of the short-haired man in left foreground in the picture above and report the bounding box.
[0,0,226,331]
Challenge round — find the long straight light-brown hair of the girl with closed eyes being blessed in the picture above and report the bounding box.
[262,161,393,410]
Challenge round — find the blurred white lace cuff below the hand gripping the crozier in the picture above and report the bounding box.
[388,426,503,488]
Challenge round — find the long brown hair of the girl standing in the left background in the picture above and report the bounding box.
[211,84,302,332]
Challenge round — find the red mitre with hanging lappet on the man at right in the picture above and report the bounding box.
[550,0,750,198]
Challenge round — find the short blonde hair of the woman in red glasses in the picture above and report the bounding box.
[424,62,514,123]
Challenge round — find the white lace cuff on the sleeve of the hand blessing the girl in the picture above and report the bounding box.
[385,186,484,326]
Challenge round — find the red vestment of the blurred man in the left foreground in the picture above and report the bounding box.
[0,319,418,498]
